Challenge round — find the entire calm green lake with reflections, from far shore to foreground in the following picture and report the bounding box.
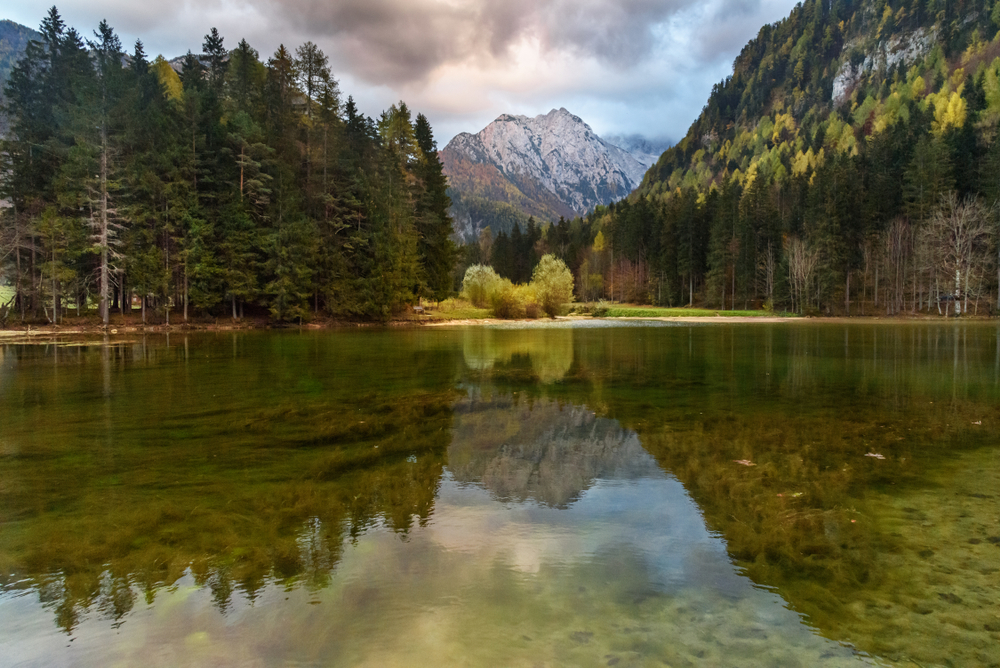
[0,322,1000,666]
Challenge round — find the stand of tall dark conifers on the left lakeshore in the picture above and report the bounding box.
[0,7,455,323]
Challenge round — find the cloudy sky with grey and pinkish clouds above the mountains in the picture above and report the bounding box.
[0,0,796,146]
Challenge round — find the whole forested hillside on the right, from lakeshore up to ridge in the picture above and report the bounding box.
[470,0,1000,315]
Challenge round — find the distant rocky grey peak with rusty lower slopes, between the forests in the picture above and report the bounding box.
[441,109,646,239]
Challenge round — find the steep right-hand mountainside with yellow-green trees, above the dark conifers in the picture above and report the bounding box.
[636,0,1000,196]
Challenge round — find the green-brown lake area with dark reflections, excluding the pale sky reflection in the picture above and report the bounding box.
[0,323,1000,666]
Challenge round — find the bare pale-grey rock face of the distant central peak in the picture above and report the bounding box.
[441,109,646,220]
